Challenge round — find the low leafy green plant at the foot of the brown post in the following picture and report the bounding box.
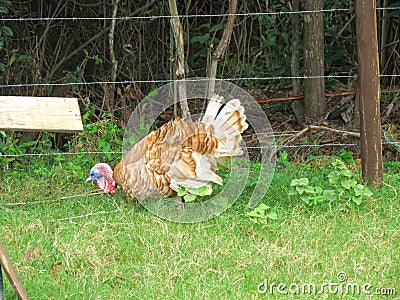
[289,159,372,207]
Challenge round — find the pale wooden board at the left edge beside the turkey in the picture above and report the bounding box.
[0,96,83,132]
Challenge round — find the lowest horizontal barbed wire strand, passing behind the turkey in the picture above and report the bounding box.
[0,142,400,158]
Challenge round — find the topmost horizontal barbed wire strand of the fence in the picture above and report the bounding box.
[1,7,400,22]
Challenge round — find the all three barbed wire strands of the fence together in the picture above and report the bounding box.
[0,6,400,158]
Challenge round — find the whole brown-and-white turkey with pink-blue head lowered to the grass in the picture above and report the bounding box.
[86,95,248,199]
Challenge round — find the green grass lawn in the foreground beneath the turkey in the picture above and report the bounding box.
[0,158,400,299]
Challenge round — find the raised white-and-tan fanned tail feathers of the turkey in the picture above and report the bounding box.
[201,95,249,157]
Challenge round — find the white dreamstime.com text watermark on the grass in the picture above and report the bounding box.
[257,272,397,296]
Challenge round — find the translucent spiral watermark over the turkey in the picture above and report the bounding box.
[123,78,276,223]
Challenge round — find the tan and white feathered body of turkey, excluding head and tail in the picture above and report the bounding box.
[114,118,222,199]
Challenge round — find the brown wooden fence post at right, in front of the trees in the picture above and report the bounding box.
[355,0,383,185]
